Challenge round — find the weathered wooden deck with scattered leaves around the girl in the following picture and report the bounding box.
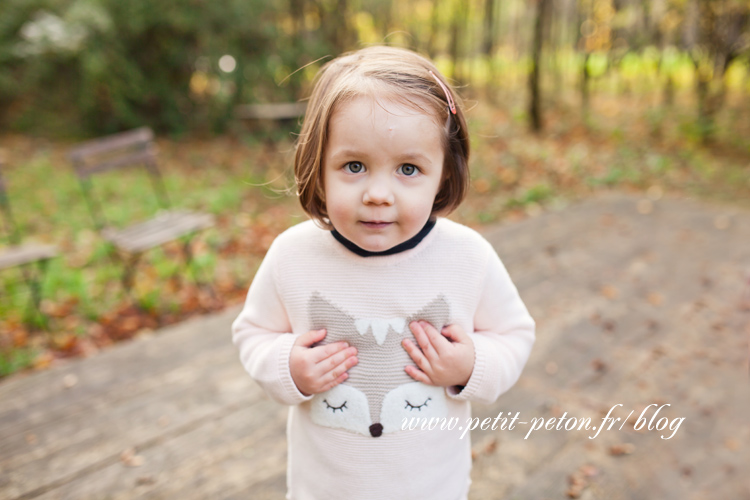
[0,192,750,500]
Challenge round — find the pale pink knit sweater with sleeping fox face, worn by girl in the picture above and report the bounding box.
[232,218,534,500]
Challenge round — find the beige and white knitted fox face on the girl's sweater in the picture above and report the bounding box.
[308,292,450,437]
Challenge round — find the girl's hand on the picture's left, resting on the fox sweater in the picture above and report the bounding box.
[289,330,358,396]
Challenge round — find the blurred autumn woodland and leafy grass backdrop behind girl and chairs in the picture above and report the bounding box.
[0,0,750,377]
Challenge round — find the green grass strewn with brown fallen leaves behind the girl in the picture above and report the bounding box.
[0,85,750,377]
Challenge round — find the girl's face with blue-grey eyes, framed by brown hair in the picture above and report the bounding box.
[323,96,443,252]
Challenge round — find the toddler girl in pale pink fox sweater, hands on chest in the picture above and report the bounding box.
[233,47,534,500]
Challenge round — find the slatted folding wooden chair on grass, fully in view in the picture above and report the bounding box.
[68,127,214,292]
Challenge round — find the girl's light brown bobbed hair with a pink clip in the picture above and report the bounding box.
[294,46,469,229]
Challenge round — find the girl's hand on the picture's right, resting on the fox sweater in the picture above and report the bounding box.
[402,321,474,387]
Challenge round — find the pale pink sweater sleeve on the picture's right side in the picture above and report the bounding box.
[447,242,535,404]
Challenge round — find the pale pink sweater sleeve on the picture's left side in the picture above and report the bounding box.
[232,240,312,405]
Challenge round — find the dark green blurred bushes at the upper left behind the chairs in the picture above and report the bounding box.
[0,0,326,135]
